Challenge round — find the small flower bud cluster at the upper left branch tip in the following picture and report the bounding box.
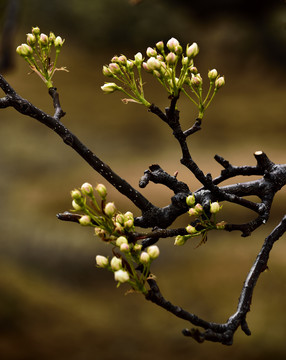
[16,27,67,88]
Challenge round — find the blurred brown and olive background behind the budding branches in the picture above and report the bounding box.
[0,0,286,360]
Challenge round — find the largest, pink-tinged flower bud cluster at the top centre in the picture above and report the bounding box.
[101,38,225,118]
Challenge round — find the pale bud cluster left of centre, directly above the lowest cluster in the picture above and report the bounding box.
[71,182,134,242]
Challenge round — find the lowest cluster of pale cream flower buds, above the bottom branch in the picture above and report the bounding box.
[95,242,160,294]
